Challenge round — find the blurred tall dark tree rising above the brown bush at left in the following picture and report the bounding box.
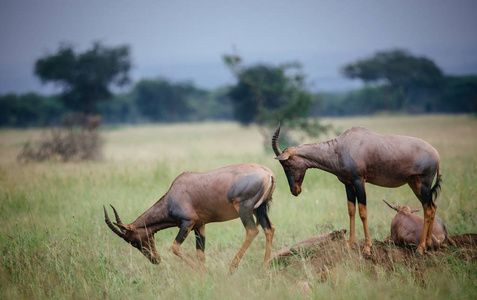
[34,42,131,114]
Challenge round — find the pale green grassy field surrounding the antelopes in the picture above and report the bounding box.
[0,115,477,299]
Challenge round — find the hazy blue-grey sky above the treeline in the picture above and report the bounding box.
[0,0,477,94]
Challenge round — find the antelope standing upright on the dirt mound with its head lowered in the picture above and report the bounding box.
[272,124,441,256]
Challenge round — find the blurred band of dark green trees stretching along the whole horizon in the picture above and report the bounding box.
[0,43,477,128]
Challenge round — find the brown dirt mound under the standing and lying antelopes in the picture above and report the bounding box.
[272,229,477,280]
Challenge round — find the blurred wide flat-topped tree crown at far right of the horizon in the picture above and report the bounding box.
[342,49,443,109]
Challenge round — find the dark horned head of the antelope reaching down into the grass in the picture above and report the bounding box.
[103,205,161,264]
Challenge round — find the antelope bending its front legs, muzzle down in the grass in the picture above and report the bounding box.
[103,163,275,272]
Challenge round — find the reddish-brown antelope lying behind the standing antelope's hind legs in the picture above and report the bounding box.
[383,200,456,248]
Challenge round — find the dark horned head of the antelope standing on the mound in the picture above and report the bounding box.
[272,124,307,196]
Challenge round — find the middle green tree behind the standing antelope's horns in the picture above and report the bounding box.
[223,55,330,145]
